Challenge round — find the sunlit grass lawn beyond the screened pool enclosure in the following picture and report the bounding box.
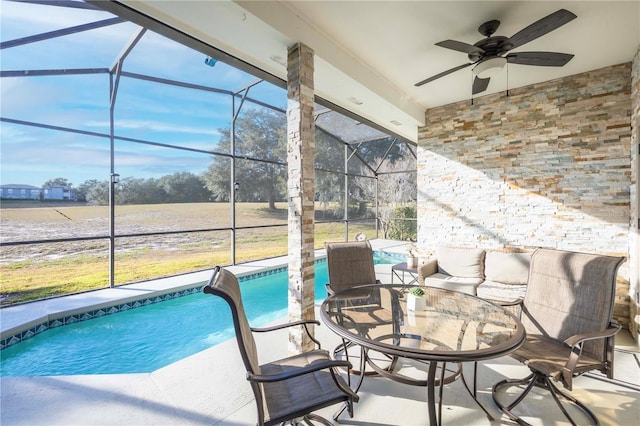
[0,203,374,306]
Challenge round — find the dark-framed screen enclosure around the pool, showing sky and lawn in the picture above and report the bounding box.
[0,1,416,305]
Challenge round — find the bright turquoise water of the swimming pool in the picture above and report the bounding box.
[0,253,399,376]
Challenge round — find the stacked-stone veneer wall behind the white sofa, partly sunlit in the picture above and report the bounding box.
[418,63,632,327]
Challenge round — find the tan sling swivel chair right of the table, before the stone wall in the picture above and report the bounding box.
[492,249,624,424]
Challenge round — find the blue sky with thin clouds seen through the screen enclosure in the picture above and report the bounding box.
[0,0,286,186]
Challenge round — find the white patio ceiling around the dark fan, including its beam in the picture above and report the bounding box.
[122,0,640,141]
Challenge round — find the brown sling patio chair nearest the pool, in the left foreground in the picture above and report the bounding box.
[203,266,358,425]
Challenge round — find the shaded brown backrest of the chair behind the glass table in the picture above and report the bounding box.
[324,241,376,292]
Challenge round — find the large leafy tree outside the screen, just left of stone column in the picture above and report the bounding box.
[202,109,287,209]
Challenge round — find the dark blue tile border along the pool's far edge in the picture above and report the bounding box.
[0,259,300,350]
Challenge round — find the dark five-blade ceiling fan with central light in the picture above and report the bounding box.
[415,9,576,95]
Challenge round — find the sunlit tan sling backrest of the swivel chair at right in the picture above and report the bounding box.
[521,249,624,361]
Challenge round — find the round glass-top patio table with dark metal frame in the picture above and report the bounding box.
[320,284,525,425]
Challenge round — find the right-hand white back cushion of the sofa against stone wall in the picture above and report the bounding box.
[484,251,531,285]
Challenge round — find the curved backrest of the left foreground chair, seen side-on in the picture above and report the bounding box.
[202,266,260,374]
